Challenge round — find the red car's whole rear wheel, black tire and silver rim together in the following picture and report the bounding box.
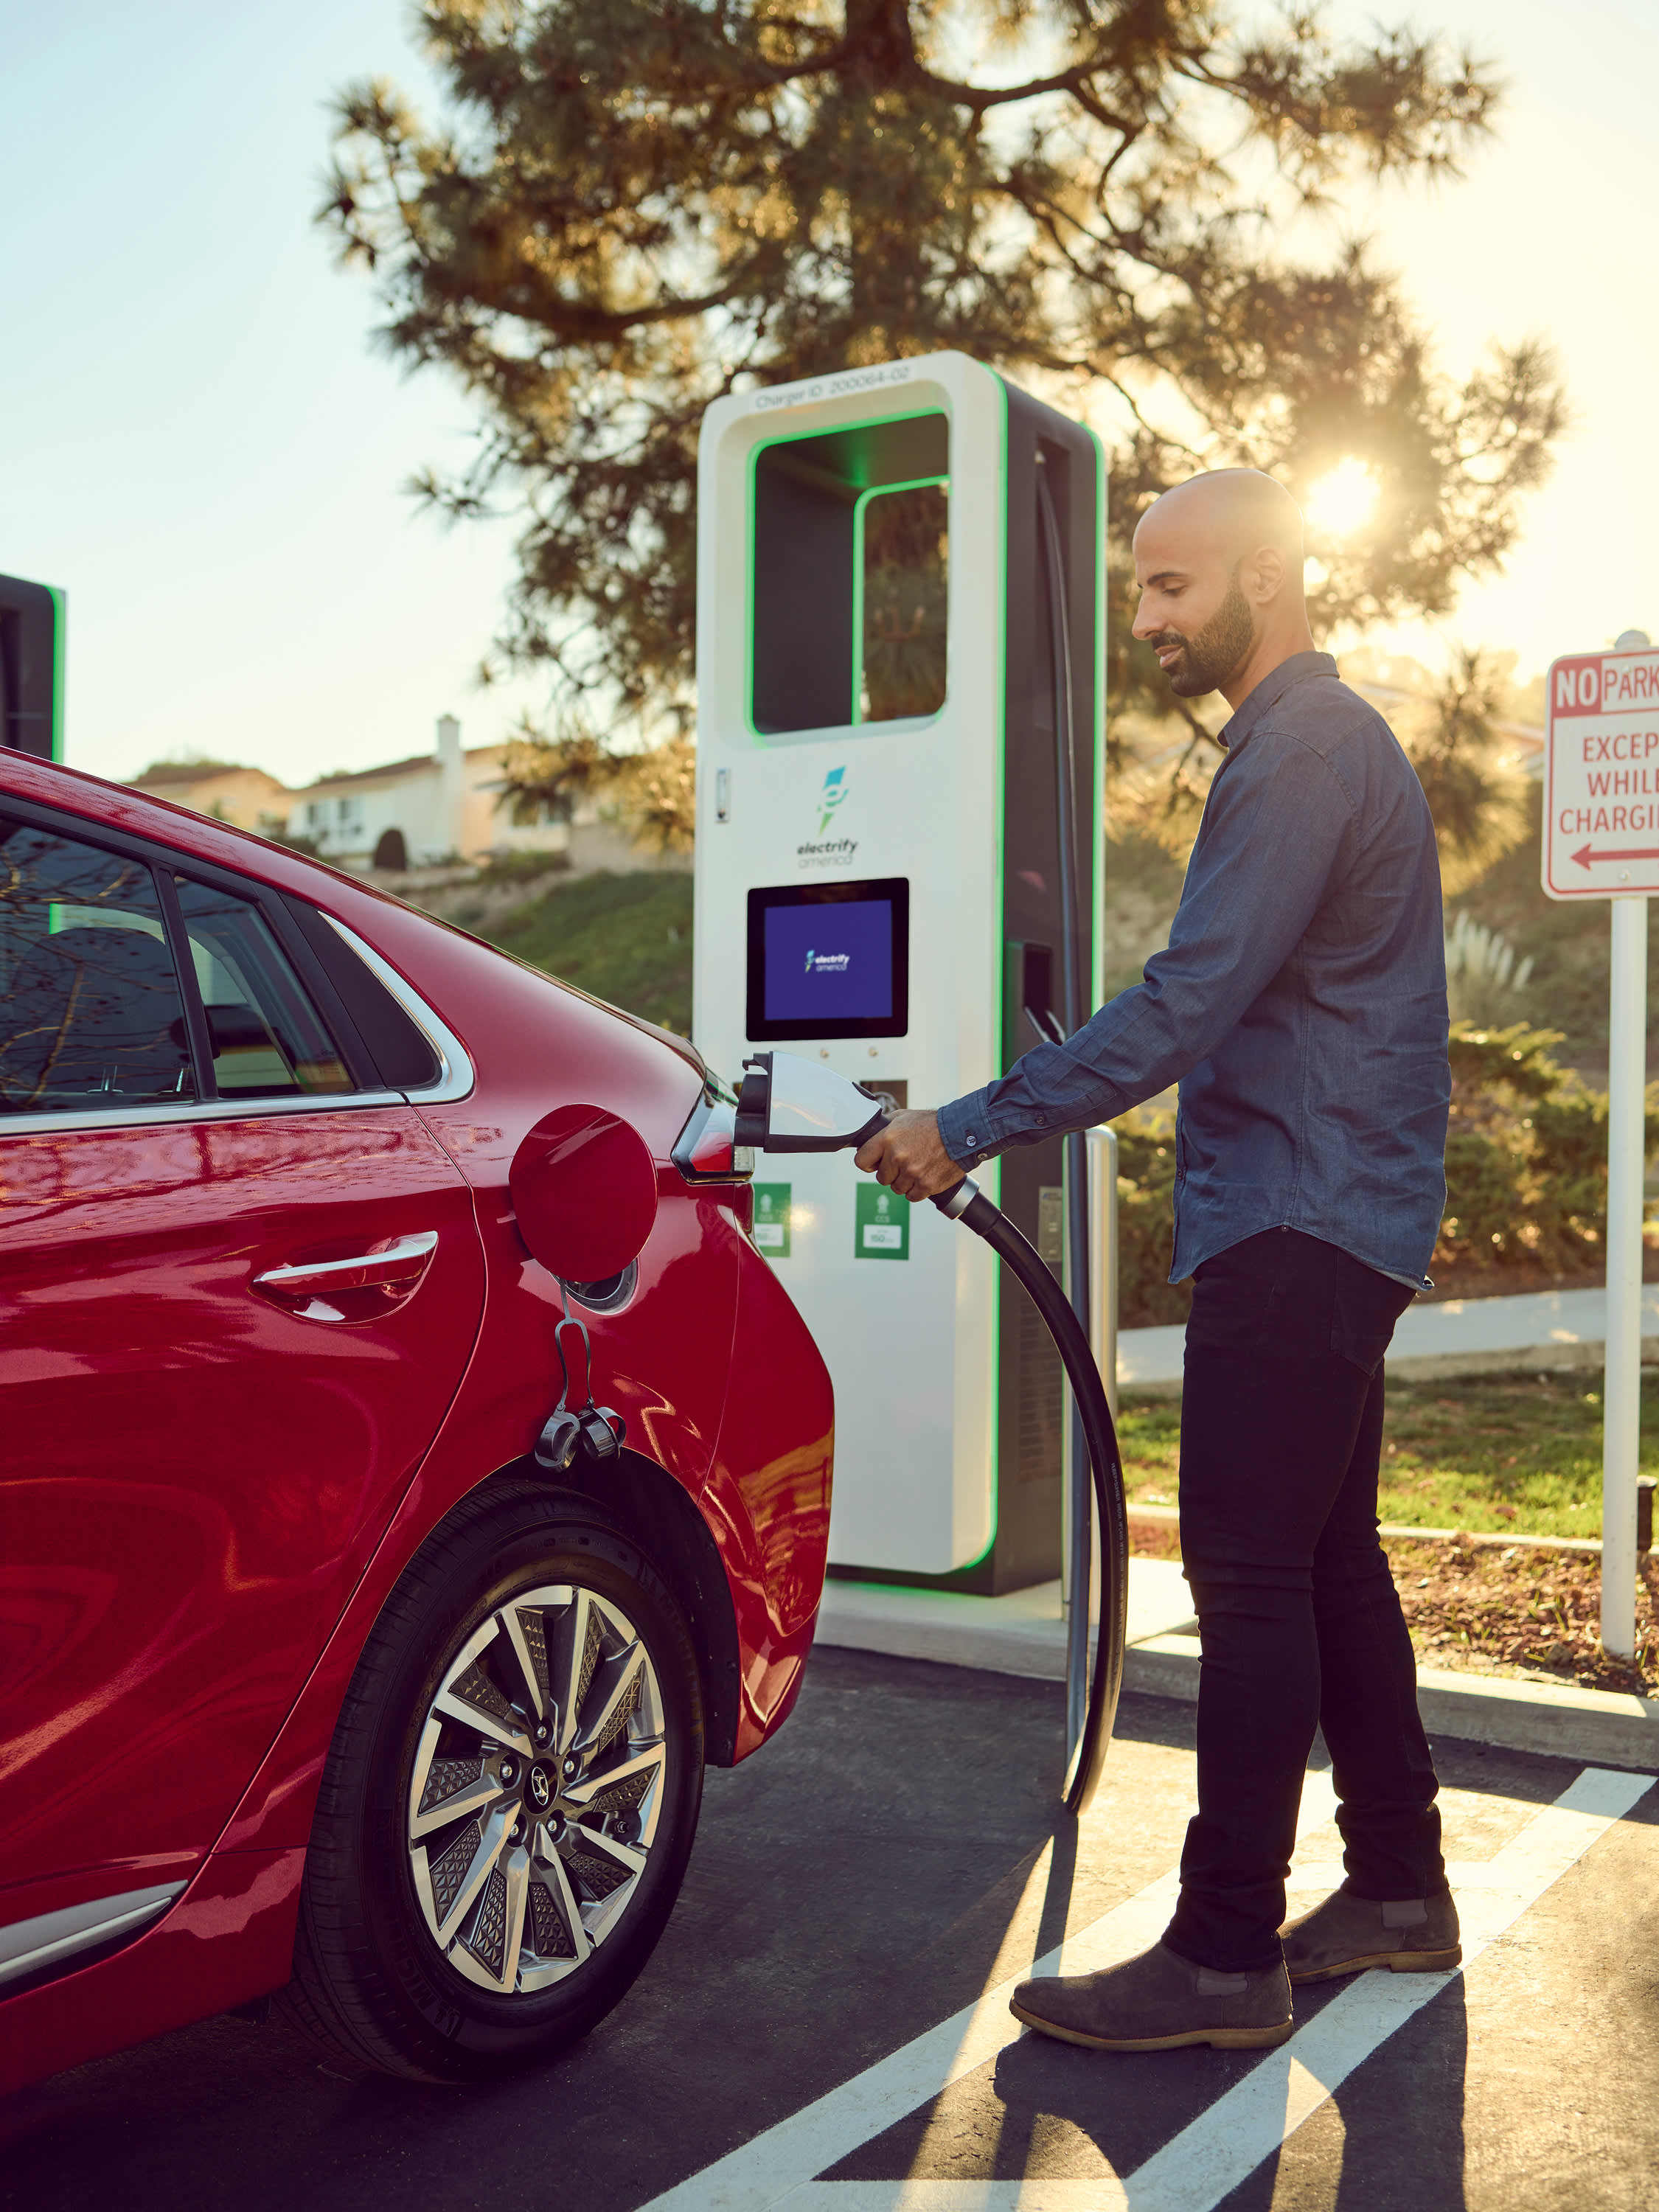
[283,1484,703,2081]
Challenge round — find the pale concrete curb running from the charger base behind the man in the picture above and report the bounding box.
[818,1562,1659,1774]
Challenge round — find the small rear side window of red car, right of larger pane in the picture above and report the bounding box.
[175,876,356,1099]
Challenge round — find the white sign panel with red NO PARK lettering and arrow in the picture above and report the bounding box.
[1542,650,1659,898]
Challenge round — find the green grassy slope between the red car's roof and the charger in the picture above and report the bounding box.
[482,874,692,1037]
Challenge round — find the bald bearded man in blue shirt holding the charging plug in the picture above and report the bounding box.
[858,469,1460,2051]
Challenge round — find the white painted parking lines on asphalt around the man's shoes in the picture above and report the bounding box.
[644,1767,1652,2212]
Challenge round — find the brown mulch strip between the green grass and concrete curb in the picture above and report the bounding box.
[1128,1513,1659,1697]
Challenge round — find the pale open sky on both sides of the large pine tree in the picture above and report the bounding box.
[0,0,1659,783]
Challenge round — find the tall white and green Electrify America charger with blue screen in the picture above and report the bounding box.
[692,354,1106,1593]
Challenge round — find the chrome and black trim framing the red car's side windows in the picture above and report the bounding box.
[0,790,476,1137]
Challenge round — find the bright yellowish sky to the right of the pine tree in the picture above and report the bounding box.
[1336,0,1659,677]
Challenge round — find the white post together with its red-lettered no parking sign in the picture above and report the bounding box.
[1542,630,1659,1659]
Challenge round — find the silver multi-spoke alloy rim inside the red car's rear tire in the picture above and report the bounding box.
[407,1584,668,1997]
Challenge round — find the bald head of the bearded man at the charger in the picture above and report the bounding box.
[1135,469,1312,706]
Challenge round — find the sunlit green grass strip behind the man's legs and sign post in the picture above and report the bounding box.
[1117,1367,1659,1535]
